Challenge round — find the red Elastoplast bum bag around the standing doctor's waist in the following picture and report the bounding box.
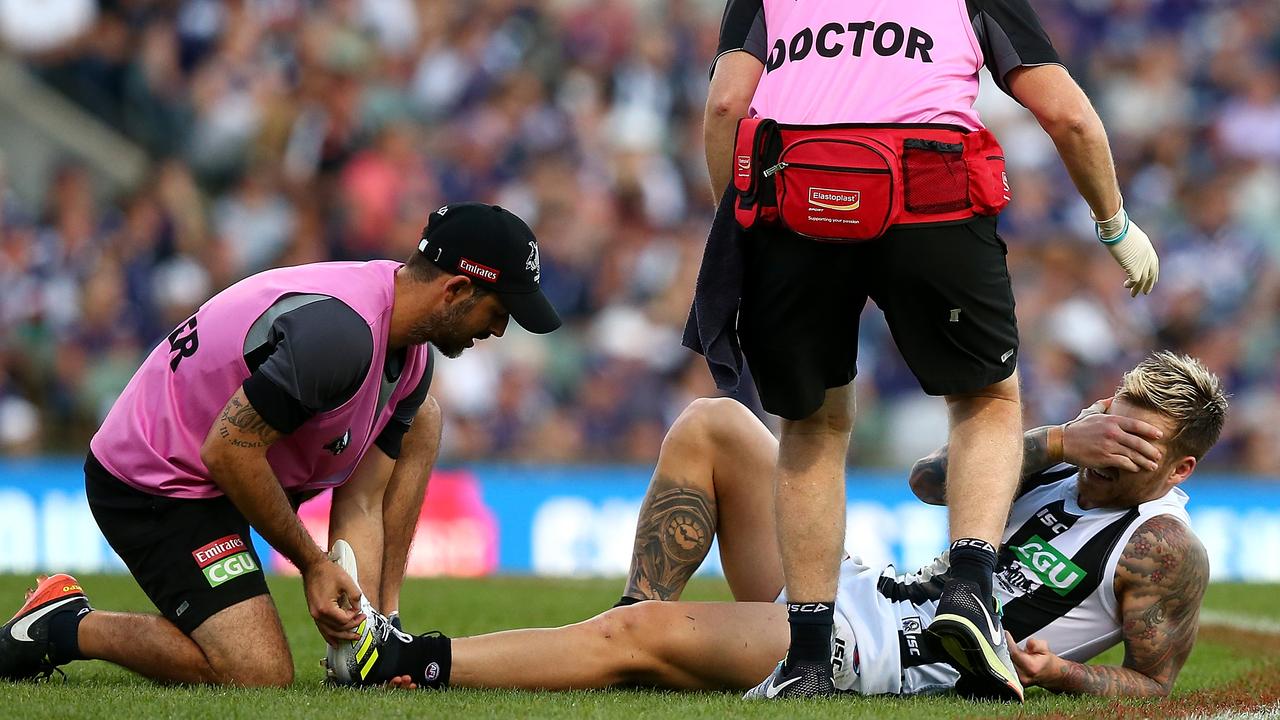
[733,118,1010,242]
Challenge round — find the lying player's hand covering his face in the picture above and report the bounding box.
[1062,400,1164,473]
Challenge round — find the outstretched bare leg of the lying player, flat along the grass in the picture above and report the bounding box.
[449,602,787,691]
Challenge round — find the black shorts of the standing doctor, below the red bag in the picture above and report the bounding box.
[739,217,1018,420]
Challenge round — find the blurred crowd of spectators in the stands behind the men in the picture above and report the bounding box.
[0,0,1280,477]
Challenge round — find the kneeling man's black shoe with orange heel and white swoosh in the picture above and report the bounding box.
[0,573,92,680]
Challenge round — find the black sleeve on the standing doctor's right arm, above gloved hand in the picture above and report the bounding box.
[968,0,1062,100]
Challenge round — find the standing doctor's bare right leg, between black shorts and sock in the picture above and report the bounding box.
[946,374,1023,546]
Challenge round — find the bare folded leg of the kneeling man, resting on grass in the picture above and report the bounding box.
[79,594,293,687]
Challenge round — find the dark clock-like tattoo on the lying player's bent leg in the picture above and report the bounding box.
[626,475,716,600]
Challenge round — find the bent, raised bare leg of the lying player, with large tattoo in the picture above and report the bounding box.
[626,398,782,602]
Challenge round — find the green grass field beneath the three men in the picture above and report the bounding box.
[0,575,1280,720]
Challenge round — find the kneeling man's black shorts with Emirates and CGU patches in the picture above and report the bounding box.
[84,452,268,635]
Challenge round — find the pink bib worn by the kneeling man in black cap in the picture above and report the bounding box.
[90,260,429,498]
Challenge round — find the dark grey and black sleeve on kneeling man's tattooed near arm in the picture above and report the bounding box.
[243,299,374,433]
